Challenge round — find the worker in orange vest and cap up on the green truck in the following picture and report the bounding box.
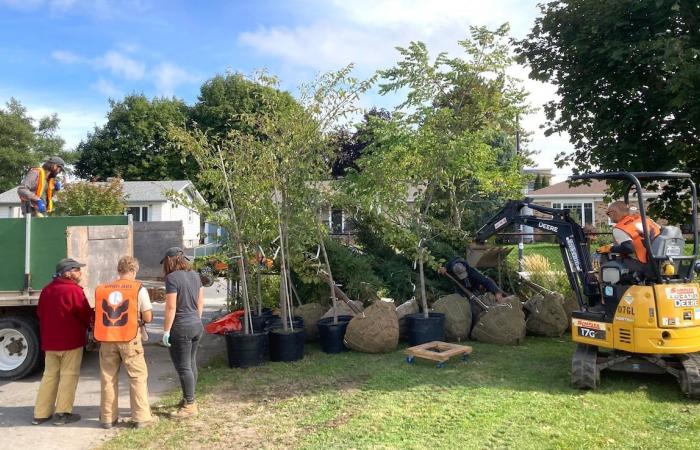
[17,156,66,217]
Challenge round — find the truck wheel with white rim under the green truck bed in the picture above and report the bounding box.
[0,316,41,380]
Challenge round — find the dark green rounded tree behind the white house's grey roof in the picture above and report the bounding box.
[76,94,191,181]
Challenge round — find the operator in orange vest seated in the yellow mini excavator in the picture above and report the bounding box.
[598,201,661,274]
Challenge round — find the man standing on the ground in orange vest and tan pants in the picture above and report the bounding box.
[94,256,157,429]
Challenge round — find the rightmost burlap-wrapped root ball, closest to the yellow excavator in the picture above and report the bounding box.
[524,292,569,337]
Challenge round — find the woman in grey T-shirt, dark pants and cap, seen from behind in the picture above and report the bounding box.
[160,247,204,419]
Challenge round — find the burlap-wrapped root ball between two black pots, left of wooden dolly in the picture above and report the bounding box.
[345,301,399,353]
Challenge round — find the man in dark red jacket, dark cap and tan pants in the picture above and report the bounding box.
[32,258,94,425]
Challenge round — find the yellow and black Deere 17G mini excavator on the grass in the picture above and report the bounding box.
[475,172,700,399]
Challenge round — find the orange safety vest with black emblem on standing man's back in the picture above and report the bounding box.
[95,280,141,342]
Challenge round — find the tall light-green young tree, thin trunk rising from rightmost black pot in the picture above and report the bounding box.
[346,26,525,317]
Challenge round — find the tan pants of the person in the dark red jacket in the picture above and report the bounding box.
[34,347,83,419]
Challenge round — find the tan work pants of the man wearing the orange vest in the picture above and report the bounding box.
[100,333,152,423]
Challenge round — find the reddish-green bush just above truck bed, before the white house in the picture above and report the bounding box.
[55,179,126,216]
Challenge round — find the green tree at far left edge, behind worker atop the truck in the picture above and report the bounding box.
[0,98,66,192]
